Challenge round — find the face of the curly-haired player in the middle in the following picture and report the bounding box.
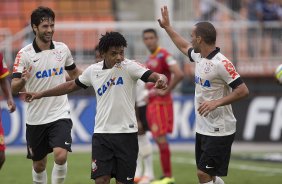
[102,46,124,67]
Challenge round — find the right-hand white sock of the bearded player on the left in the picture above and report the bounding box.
[52,162,68,184]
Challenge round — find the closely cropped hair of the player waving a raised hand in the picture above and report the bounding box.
[195,22,216,45]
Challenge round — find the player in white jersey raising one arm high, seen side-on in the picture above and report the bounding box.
[158,6,249,184]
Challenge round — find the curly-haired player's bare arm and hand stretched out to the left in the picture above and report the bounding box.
[20,80,81,102]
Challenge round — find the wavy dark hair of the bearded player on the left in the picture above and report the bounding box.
[30,6,55,34]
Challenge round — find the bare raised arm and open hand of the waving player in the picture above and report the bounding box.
[158,6,190,55]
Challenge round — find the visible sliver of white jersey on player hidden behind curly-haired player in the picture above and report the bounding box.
[136,80,149,107]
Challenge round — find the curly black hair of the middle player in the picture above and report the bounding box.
[98,32,127,53]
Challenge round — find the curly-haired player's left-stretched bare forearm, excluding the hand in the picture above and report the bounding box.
[40,80,80,97]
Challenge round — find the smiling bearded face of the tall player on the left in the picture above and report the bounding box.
[33,18,55,43]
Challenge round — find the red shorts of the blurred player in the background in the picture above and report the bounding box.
[147,101,173,138]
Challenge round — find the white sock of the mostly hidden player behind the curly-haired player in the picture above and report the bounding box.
[138,134,154,179]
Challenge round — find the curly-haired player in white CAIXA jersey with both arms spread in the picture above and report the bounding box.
[22,32,167,184]
